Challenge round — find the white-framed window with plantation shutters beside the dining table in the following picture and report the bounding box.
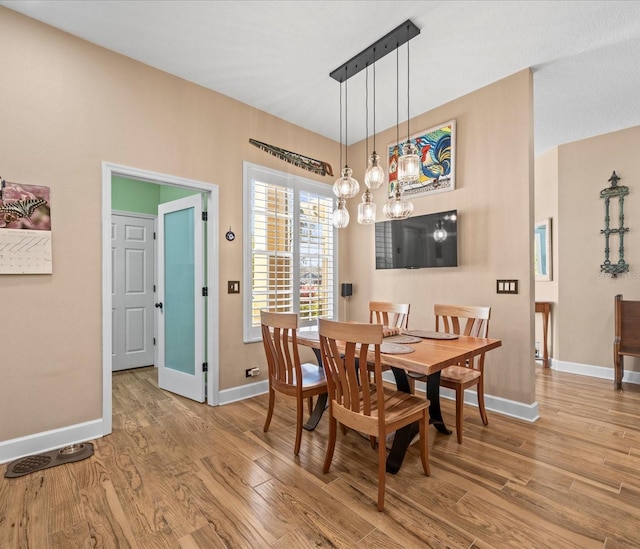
[243,162,337,342]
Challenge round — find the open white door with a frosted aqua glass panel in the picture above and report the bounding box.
[155,194,205,402]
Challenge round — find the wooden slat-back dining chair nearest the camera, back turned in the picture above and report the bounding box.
[318,319,430,511]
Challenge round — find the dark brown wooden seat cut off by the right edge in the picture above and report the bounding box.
[613,294,640,389]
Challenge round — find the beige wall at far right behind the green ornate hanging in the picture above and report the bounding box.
[554,126,640,371]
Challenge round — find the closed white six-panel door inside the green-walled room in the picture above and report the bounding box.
[111,214,154,372]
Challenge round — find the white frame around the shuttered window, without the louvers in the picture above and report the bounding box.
[242,161,339,343]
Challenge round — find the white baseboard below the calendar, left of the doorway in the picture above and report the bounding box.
[0,419,104,463]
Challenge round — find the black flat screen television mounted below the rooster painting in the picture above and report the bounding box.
[375,210,458,269]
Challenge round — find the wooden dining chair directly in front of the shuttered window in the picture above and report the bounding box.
[260,311,327,456]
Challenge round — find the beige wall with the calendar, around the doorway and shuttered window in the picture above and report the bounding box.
[0,7,339,441]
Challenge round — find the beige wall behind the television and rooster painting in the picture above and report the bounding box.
[341,71,535,403]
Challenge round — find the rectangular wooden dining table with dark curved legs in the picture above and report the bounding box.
[297,330,502,474]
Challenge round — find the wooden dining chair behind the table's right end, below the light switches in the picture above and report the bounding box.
[408,305,491,443]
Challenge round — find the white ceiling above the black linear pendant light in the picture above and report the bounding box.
[0,0,640,154]
